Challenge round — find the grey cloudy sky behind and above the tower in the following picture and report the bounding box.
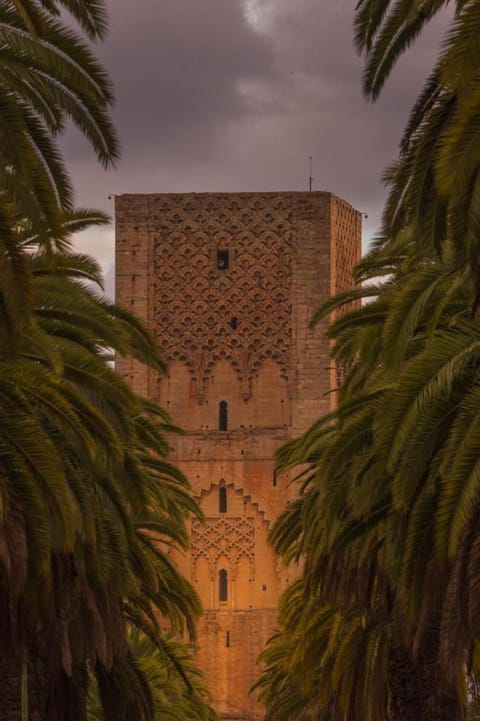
[65,0,452,290]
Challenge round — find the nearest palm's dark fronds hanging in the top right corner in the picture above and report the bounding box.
[355,0,480,306]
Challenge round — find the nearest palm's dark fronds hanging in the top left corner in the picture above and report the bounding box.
[0,0,118,353]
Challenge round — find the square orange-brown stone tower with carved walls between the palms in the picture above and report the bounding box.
[115,192,361,721]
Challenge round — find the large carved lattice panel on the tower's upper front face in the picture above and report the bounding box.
[152,194,293,394]
